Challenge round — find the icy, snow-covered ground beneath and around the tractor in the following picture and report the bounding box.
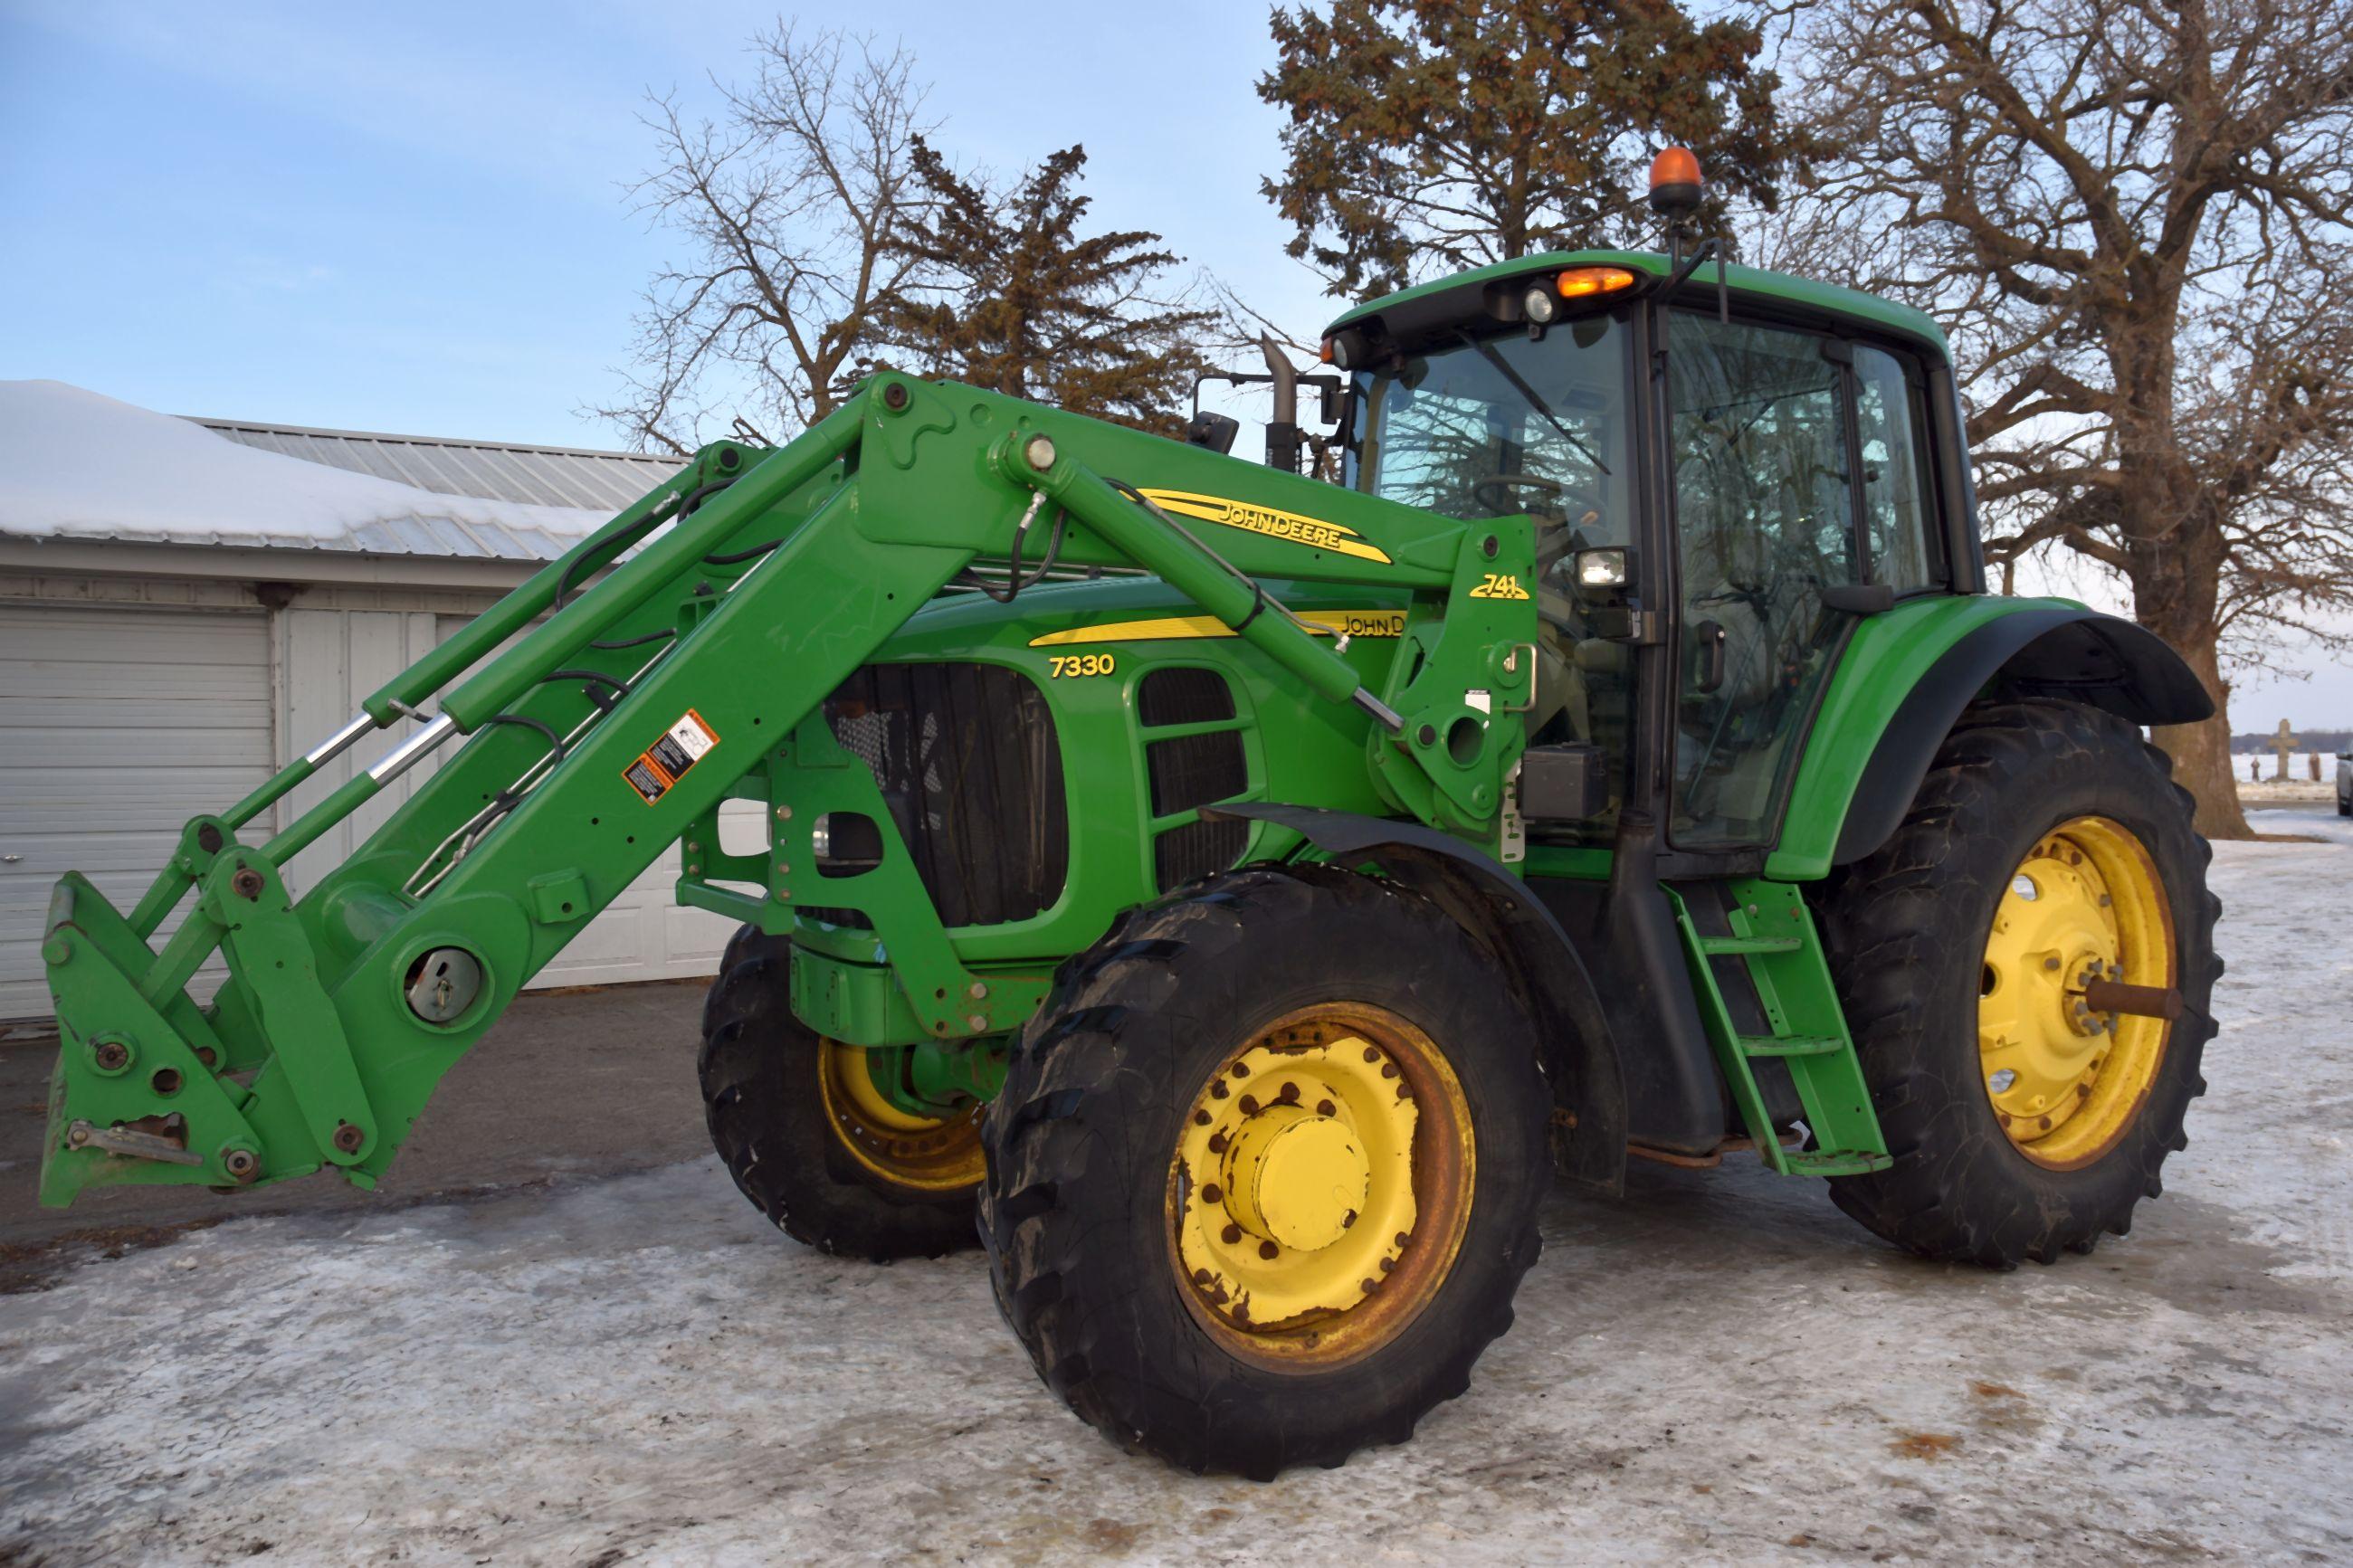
[0,813,2353,1568]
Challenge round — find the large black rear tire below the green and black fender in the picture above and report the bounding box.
[1819,703,2221,1269]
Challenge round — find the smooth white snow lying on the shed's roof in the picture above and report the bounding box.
[0,381,682,559]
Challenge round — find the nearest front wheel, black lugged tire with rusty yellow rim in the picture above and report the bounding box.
[981,868,1550,1478]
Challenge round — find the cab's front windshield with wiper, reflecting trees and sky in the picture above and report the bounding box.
[1348,315,1633,543]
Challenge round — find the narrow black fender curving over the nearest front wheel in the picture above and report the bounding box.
[1203,802,1626,1194]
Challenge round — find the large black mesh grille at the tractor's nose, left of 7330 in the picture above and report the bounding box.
[805,663,1071,927]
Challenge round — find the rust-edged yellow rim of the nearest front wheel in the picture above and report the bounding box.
[1167,1002,1475,1366]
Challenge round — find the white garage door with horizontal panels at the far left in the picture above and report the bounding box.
[0,604,271,1018]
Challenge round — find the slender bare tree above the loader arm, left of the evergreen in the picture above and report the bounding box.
[595,24,932,451]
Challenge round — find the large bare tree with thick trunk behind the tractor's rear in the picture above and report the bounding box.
[1779,0,2353,837]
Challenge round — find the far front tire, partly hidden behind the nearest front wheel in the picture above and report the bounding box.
[699,927,981,1262]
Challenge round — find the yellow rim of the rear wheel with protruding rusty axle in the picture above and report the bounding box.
[1977,816,2177,1171]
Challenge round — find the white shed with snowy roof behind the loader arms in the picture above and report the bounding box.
[0,381,729,1021]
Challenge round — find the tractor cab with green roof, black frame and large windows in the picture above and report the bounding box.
[1325,252,1979,853]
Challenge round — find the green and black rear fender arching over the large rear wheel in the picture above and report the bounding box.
[1765,594,2215,881]
